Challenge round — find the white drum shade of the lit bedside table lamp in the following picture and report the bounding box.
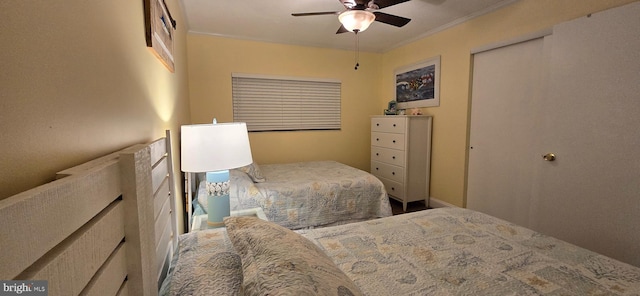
[180,122,253,173]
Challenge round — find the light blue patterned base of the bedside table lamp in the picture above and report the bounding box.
[206,170,231,228]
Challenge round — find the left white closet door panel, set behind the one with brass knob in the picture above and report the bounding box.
[467,37,546,226]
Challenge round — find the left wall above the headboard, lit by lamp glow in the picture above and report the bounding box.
[0,0,190,225]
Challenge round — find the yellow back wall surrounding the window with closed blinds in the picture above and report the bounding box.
[187,34,384,171]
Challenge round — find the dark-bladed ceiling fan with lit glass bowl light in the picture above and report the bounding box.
[291,0,411,34]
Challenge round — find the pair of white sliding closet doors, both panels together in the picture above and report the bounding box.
[467,2,640,266]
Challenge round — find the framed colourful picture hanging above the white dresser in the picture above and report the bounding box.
[395,56,440,109]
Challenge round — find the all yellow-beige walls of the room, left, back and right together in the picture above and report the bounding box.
[0,0,633,215]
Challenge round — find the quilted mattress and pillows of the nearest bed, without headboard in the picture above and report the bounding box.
[161,208,640,295]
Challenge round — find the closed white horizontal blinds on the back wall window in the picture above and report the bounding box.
[232,73,341,131]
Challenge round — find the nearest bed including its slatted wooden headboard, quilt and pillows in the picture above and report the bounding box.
[0,135,640,296]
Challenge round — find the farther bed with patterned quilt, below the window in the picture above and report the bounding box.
[194,161,391,229]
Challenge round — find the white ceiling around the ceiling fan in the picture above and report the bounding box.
[178,0,517,52]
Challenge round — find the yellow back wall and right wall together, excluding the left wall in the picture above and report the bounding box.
[187,0,633,206]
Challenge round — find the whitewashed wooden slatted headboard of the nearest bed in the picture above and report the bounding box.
[0,131,178,295]
